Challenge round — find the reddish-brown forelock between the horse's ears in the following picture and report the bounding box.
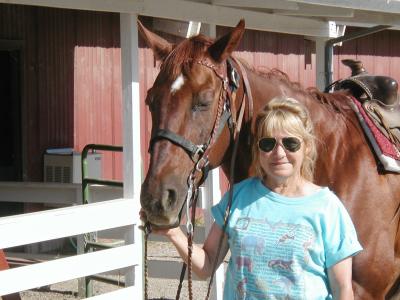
[160,34,213,80]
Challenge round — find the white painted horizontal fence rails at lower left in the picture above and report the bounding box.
[0,199,142,299]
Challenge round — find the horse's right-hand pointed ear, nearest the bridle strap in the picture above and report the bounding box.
[208,19,244,62]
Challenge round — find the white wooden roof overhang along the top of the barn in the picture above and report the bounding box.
[0,0,400,38]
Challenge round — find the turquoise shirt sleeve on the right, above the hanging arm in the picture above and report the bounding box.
[324,196,363,268]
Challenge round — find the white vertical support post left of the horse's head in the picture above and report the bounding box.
[119,12,143,299]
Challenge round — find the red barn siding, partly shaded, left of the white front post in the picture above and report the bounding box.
[0,4,122,181]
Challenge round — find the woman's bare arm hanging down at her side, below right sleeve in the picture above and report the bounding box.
[328,256,354,300]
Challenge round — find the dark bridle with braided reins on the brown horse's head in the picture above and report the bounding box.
[144,58,253,300]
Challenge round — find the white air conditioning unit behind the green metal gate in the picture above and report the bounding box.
[43,151,102,183]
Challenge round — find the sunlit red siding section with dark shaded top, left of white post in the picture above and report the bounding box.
[74,11,122,179]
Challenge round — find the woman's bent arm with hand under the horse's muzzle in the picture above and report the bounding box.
[154,223,229,279]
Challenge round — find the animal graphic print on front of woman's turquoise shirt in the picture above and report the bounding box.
[231,217,315,299]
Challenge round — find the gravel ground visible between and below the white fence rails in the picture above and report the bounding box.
[14,238,228,300]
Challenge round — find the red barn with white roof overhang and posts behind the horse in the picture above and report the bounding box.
[0,0,400,294]
